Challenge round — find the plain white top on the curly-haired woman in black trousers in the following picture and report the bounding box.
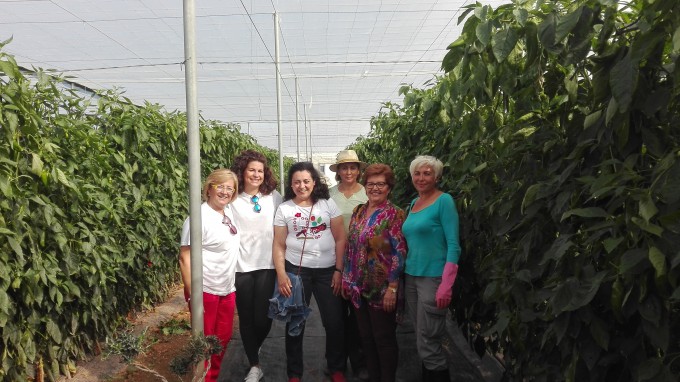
[231,190,283,272]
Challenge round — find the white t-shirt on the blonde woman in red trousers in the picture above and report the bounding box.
[180,203,240,296]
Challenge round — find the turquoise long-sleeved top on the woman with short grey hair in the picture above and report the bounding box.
[402,193,460,277]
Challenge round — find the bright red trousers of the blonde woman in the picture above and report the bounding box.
[203,292,236,382]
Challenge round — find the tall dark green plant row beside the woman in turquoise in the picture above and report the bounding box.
[353,0,680,381]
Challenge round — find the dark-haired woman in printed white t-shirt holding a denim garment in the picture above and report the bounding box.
[272,162,346,382]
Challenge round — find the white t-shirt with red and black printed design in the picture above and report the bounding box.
[274,199,341,268]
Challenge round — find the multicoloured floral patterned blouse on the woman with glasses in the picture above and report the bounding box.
[342,201,408,309]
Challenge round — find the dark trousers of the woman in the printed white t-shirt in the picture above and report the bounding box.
[286,261,347,378]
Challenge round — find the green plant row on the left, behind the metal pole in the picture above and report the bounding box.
[0,41,278,381]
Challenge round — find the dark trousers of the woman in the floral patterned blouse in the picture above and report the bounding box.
[354,298,399,382]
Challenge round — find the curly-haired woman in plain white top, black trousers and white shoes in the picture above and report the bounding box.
[231,150,283,382]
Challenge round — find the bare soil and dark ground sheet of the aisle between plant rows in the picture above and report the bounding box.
[60,287,502,382]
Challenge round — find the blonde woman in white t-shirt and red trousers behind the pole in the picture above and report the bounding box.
[179,169,239,382]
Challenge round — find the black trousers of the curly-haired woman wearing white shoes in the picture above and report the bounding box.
[236,269,276,366]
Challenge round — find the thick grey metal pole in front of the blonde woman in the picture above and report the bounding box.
[184,0,203,335]
